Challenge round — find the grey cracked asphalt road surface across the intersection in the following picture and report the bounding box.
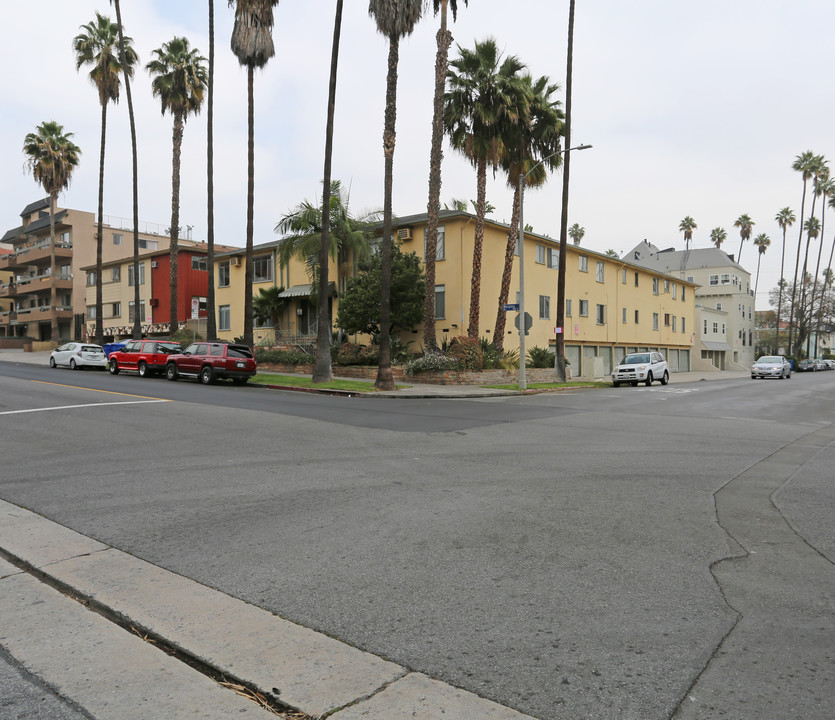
[0,363,835,720]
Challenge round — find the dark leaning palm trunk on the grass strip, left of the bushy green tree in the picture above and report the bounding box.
[313,0,342,383]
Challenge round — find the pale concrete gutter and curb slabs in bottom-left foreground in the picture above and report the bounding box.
[0,501,527,720]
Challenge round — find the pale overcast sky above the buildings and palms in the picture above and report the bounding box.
[0,0,835,309]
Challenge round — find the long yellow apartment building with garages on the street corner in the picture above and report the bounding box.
[216,210,697,377]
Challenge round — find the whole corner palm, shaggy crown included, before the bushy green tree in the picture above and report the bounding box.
[368,0,423,390]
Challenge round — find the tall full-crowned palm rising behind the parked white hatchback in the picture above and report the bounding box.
[73,12,137,345]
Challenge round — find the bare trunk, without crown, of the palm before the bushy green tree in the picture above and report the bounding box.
[374,35,400,390]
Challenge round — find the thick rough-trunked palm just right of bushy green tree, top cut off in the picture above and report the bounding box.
[423,0,468,351]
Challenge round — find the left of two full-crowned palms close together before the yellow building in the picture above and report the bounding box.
[444,38,525,338]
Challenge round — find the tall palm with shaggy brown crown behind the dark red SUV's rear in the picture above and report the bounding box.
[229,0,278,346]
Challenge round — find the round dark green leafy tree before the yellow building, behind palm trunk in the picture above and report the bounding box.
[336,243,426,340]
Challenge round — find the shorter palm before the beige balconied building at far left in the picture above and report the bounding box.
[23,121,81,342]
